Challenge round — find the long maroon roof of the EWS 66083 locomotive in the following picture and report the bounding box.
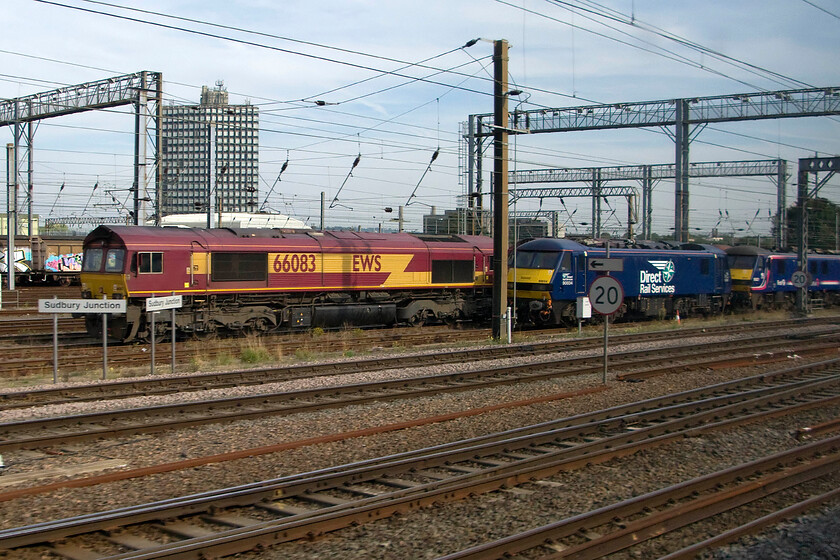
[85,225,491,250]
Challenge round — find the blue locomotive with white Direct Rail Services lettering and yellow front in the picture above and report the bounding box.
[508,239,731,325]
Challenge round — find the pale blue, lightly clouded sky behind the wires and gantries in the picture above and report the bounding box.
[0,0,840,234]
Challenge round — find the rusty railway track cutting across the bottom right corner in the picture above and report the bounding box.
[438,437,840,560]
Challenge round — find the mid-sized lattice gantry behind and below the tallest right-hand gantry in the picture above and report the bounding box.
[510,159,787,247]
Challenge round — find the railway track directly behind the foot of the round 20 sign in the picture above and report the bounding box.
[0,326,840,453]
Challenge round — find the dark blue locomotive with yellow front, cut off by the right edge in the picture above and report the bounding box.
[726,245,840,309]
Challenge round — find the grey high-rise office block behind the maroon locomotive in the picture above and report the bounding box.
[160,82,259,221]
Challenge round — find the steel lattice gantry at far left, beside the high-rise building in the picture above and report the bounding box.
[0,71,163,230]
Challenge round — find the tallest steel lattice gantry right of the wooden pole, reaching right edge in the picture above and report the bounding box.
[464,86,840,241]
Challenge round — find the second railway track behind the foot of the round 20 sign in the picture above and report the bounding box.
[0,319,832,410]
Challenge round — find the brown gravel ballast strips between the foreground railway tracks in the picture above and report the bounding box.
[0,322,840,560]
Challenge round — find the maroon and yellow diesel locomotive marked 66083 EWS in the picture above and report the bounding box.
[81,225,493,341]
